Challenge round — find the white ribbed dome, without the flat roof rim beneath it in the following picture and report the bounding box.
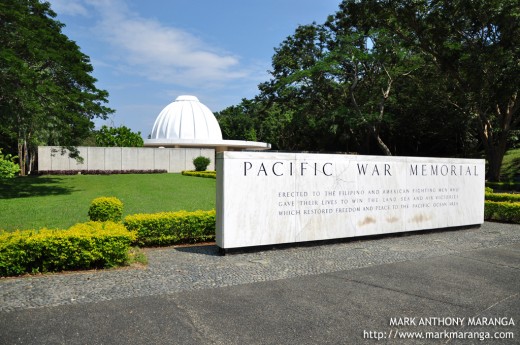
[151,96,222,140]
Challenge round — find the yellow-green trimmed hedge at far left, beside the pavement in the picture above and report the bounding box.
[0,222,136,276]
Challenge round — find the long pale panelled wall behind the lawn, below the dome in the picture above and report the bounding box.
[38,146,215,173]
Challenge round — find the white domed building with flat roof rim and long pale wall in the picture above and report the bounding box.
[38,96,271,173]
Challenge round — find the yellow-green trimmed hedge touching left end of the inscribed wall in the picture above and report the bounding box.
[124,210,216,246]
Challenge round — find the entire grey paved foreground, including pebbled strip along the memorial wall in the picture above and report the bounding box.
[0,223,520,345]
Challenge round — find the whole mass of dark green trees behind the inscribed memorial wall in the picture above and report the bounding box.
[216,0,520,180]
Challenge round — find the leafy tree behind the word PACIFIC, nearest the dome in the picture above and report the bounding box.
[256,24,345,151]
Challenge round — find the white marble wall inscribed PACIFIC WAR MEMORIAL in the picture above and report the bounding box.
[216,152,485,249]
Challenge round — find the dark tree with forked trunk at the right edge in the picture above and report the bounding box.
[362,0,520,181]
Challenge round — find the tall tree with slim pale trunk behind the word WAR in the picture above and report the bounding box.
[324,21,423,155]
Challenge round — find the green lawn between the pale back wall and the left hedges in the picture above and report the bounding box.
[0,174,216,231]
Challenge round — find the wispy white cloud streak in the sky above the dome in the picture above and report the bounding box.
[81,0,249,86]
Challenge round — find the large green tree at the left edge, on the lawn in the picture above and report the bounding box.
[0,0,113,175]
